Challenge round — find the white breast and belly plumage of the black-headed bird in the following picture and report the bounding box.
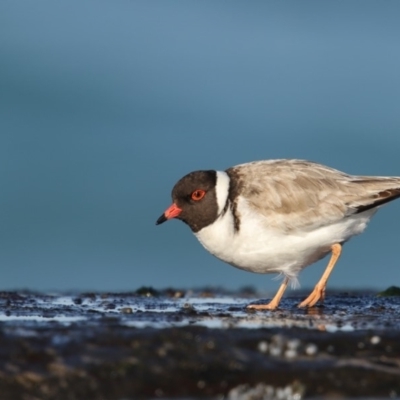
[195,205,375,278]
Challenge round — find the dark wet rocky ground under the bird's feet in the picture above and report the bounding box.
[0,288,400,400]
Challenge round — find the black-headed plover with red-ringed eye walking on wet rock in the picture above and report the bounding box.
[156,159,400,310]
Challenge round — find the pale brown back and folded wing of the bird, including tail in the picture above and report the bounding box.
[227,160,400,231]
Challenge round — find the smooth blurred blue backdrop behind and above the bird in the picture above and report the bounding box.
[0,0,400,291]
